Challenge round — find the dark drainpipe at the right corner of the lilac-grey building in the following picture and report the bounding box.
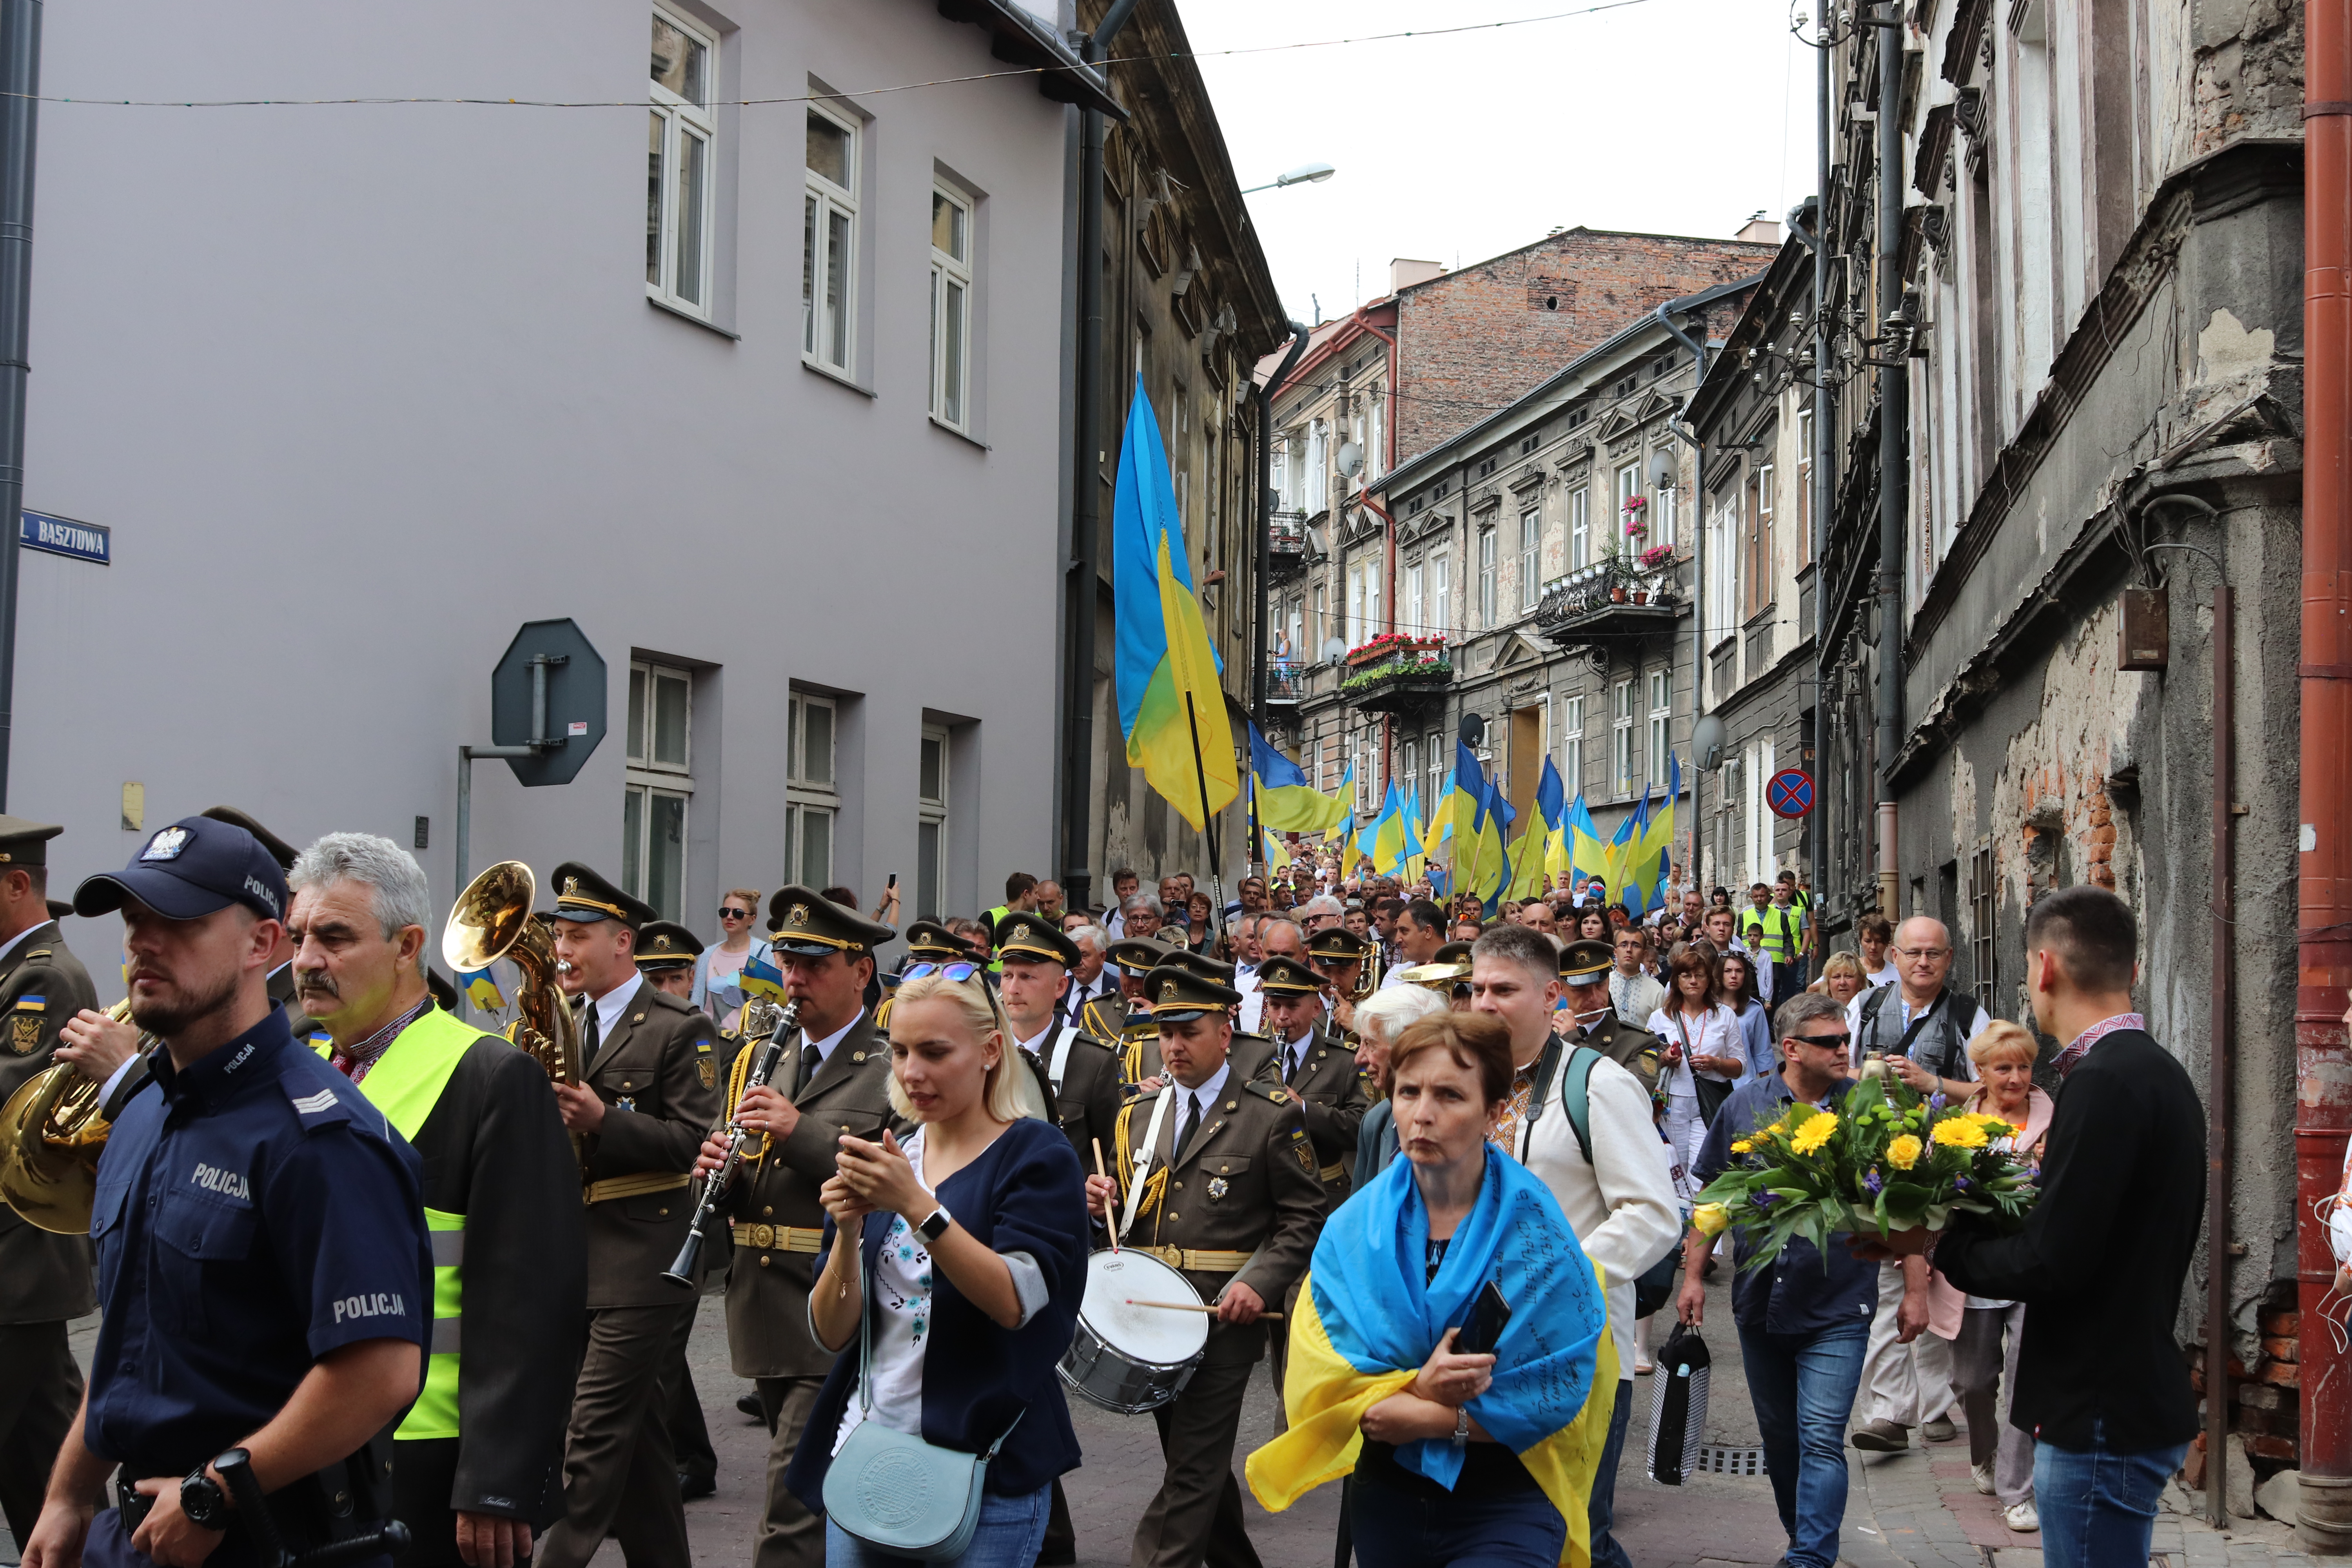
[1063,0,1138,910]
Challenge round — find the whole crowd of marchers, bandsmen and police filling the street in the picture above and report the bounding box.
[0,809,2201,1568]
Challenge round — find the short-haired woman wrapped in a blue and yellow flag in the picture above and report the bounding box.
[1247,1013,1618,1568]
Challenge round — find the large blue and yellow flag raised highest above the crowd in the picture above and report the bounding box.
[1110,376,1242,830]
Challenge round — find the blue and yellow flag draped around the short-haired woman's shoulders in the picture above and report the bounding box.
[1244,1154,1618,1568]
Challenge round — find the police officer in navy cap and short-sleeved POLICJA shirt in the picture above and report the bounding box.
[26,816,433,1568]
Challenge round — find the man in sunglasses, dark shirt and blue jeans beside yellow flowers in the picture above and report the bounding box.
[1677,992,1917,1568]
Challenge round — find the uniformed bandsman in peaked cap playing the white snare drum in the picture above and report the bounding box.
[1087,964,1322,1568]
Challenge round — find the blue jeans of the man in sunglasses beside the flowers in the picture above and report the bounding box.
[1740,1319,1870,1568]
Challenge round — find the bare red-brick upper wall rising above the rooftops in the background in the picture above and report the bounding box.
[1397,228,1780,463]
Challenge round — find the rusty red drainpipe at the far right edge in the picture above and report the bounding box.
[2296,0,2352,1552]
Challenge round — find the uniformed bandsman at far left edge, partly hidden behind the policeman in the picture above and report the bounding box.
[0,816,99,1542]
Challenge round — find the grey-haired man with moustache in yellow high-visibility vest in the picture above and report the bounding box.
[287,832,588,1568]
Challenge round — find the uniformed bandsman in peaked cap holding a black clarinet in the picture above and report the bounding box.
[703,886,898,1568]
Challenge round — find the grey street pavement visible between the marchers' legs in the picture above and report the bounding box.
[0,1274,2310,1568]
